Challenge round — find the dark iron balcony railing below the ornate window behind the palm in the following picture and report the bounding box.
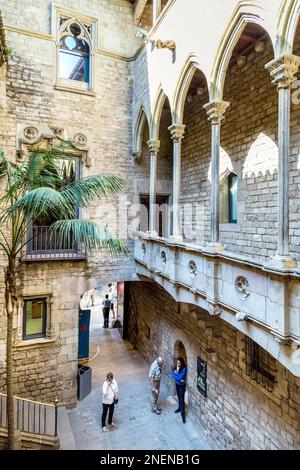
[24,226,85,261]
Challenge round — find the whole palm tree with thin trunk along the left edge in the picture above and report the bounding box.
[0,147,127,449]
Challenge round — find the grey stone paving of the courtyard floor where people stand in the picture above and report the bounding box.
[67,309,213,450]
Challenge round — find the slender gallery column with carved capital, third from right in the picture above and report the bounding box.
[169,124,185,242]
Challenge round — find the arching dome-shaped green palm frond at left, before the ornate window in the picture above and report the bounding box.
[0,188,75,221]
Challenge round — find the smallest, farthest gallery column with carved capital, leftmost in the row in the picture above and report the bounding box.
[147,140,160,237]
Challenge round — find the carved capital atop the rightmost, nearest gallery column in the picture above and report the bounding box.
[265,54,300,88]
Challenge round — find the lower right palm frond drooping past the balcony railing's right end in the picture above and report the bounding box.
[50,219,128,255]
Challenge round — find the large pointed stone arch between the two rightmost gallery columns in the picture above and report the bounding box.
[210,2,274,101]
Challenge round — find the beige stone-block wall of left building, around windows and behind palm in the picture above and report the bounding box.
[0,0,140,405]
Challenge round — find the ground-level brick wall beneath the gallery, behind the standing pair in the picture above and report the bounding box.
[132,283,300,449]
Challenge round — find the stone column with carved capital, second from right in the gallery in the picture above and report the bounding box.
[204,101,230,252]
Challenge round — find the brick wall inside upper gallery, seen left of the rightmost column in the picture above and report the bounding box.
[181,42,278,260]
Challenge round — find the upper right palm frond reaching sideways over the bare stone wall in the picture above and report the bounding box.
[60,175,125,207]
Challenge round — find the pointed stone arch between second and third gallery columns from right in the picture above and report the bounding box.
[173,55,207,124]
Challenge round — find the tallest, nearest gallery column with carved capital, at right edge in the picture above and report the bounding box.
[265,54,300,269]
